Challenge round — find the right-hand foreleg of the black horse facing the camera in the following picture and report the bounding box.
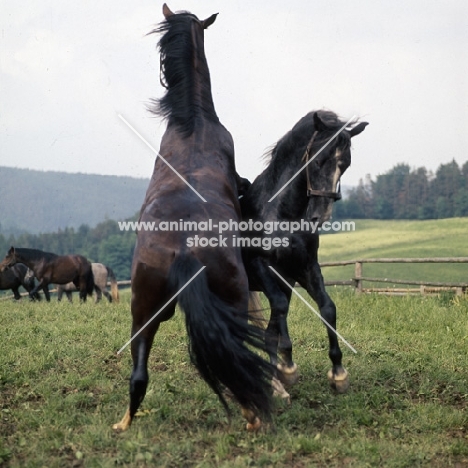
[303,263,349,393]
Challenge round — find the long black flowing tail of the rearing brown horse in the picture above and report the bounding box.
[169,254,273,419]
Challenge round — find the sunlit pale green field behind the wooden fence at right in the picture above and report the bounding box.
[319,218,468,287]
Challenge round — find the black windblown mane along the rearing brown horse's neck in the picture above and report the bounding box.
[149,12,219,137]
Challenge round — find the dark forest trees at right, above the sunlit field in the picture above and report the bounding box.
[333,160,468,219]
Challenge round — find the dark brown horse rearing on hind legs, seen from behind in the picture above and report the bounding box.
[114,5,273,430]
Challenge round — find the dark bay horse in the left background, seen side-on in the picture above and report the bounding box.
[0,247,94,301]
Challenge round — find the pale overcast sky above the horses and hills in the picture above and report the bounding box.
[0,0,468,185]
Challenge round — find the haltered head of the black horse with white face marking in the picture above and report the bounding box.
[302,111,368,225]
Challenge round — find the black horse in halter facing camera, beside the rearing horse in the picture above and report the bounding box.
[241,111,367,392]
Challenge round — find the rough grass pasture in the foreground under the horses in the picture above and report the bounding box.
[0,288,468,467]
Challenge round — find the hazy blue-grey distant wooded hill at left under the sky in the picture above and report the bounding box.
[0,166,149,234]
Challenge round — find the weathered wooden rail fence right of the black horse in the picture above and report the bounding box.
[320,257,468,295]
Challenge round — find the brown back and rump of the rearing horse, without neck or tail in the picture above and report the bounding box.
[132,121,247,300]
